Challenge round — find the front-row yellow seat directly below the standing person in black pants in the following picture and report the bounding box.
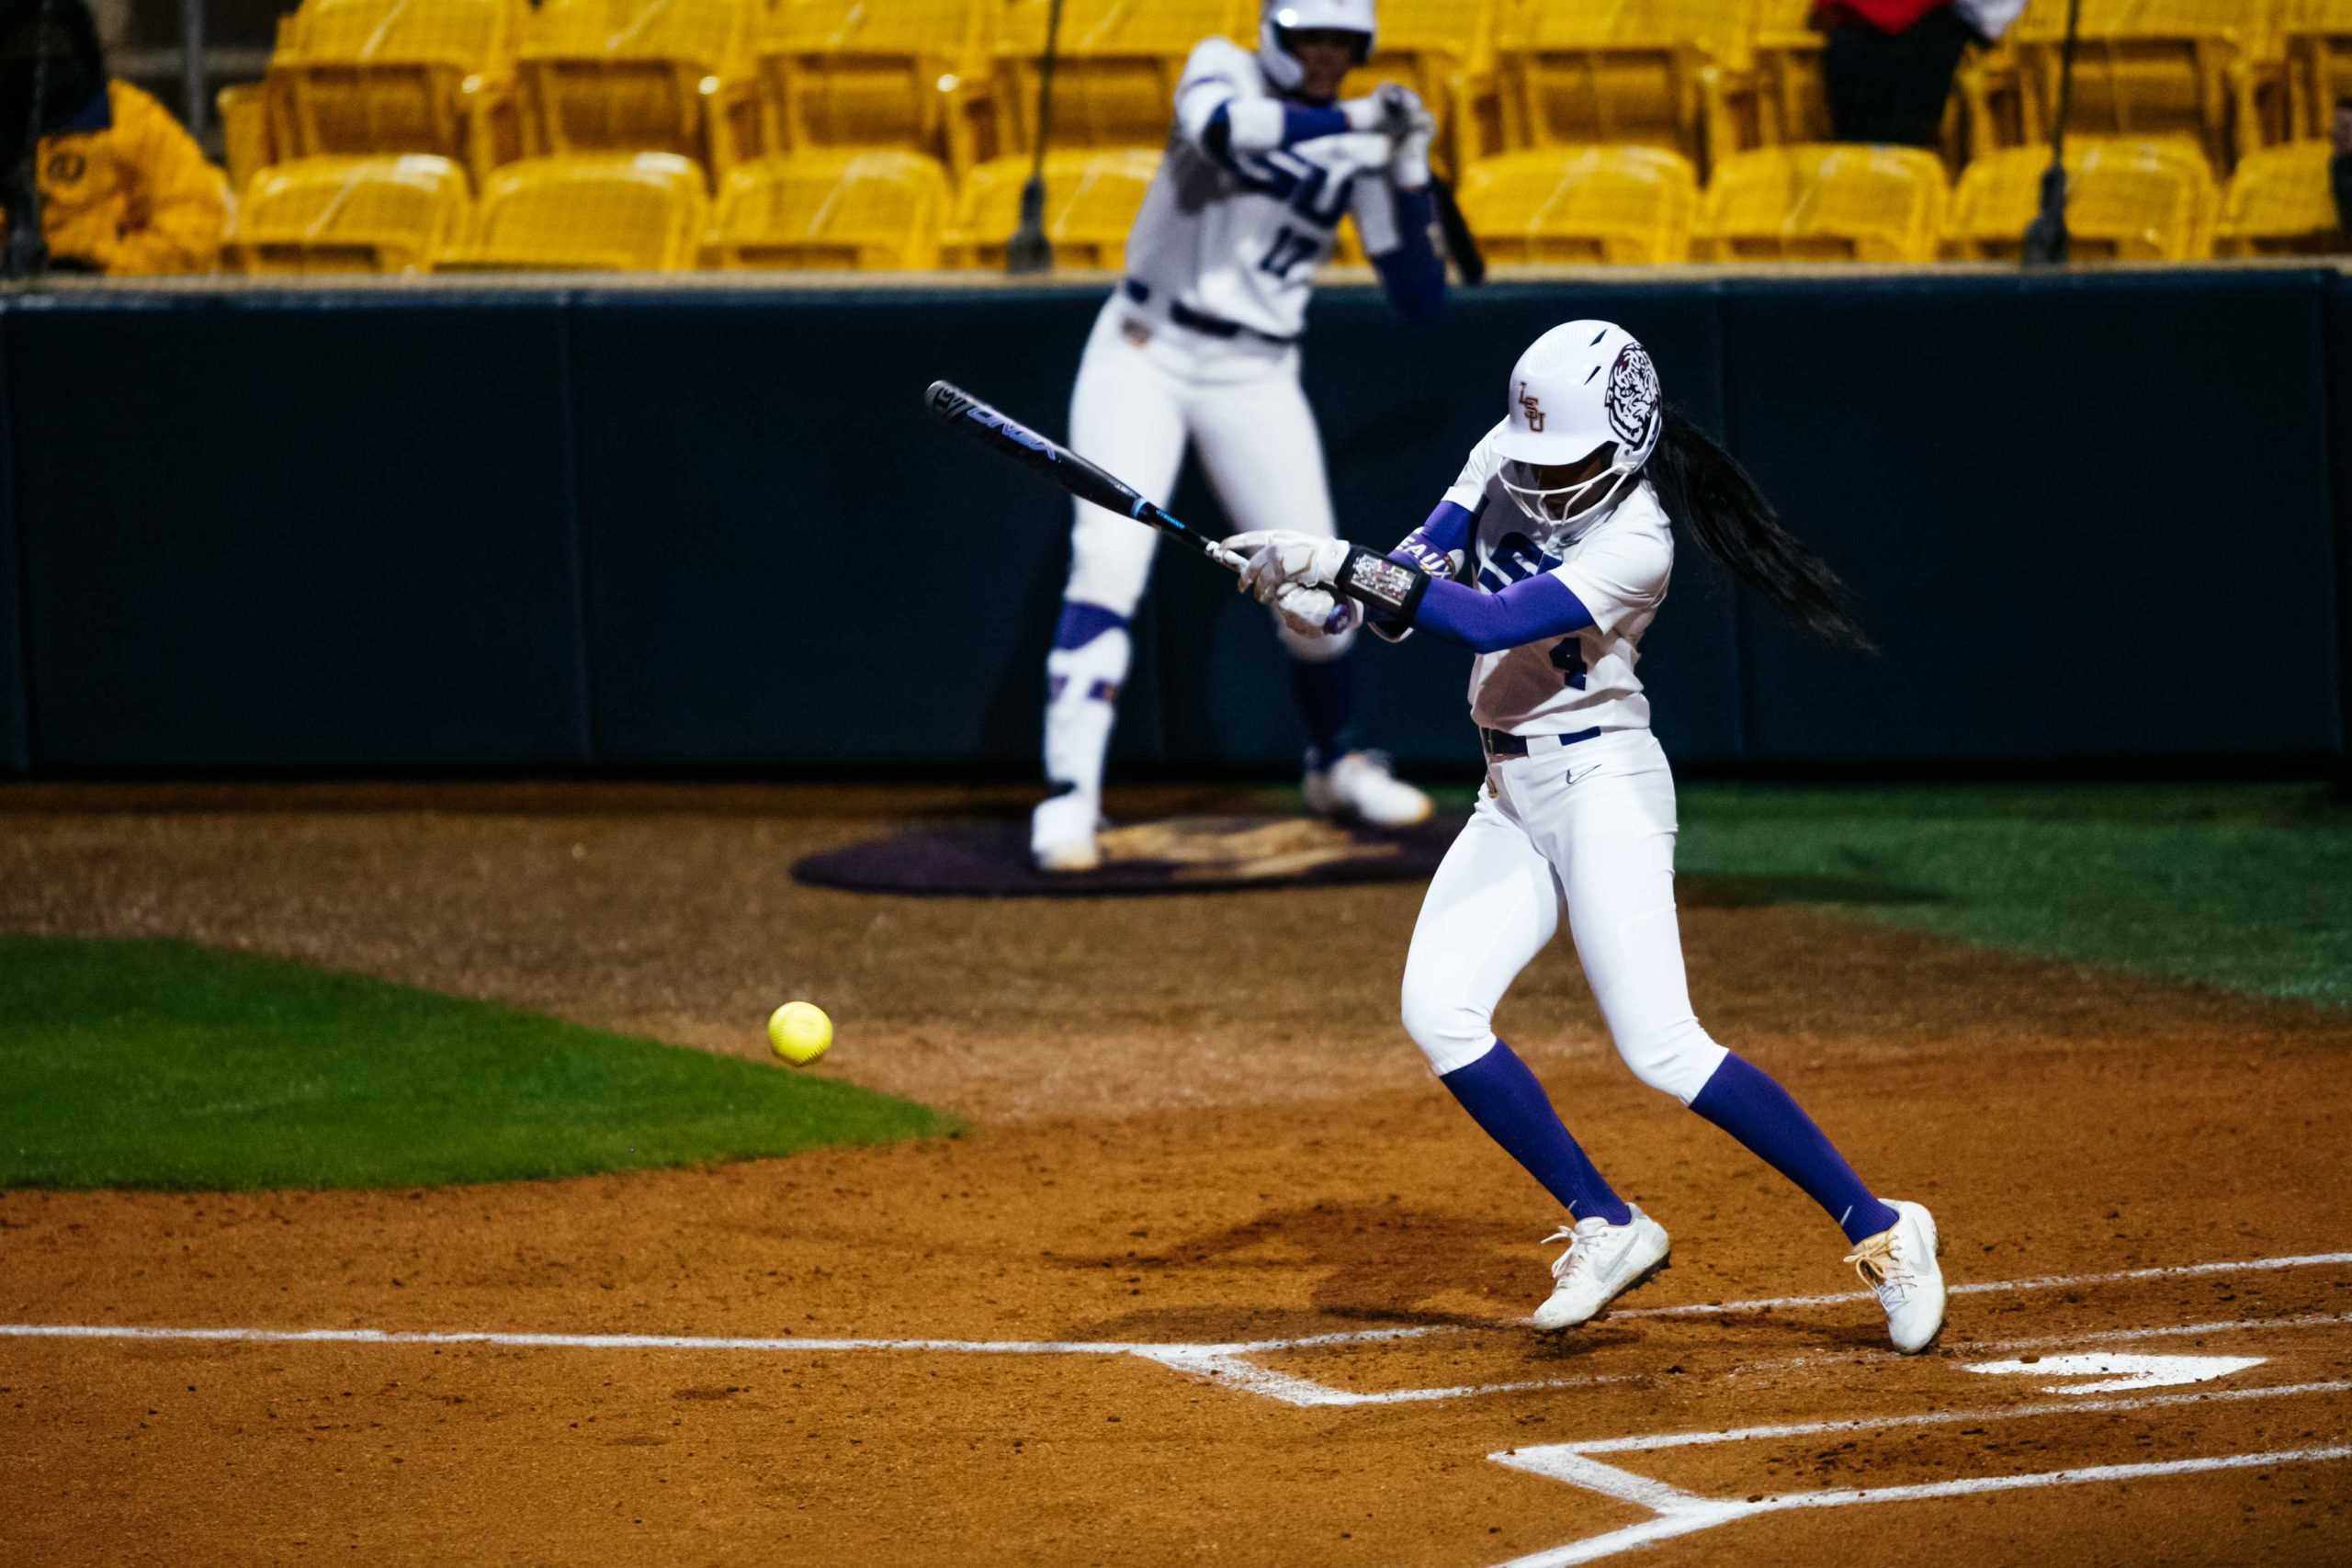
[1698,141,1948,261]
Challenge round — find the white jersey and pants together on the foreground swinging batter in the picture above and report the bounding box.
[1404,364,1724,1102]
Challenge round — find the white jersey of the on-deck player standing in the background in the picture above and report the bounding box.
[1126,38,1397,339]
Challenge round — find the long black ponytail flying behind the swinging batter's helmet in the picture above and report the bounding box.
[1642,404,1877,651]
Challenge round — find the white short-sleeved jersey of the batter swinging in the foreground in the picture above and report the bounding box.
[1446,425,1675,736]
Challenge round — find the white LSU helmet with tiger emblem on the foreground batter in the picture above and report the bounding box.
[1496,322,1665,525]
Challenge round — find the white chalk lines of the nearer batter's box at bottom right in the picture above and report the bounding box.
[1487,1382,2352,1568]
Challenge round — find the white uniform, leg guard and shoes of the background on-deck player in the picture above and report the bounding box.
[1030,0,1430,870]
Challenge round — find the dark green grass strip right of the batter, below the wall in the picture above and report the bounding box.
[1677,785,2352,1006]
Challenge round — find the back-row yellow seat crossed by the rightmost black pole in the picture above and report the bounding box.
[2016,0,2267,167]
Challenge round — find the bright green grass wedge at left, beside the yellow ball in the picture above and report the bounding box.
[0,936,953,1190]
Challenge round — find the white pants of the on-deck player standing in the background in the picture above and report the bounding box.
[1063,296,1350,660]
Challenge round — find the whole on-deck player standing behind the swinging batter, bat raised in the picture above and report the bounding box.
[1030,0,1446,870]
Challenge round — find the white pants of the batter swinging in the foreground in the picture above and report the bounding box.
[1404,728,1729,1105]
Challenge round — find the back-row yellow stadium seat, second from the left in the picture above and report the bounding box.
[515,0,755,176]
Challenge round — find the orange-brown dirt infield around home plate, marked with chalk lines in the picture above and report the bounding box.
[0,787,2352,1565]
